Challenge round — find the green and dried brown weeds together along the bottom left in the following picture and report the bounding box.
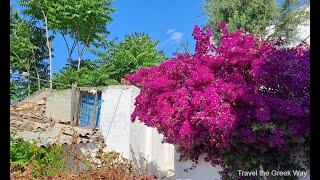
[10,135,153,180]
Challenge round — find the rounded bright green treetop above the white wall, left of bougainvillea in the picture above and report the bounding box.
[103,33,165,82]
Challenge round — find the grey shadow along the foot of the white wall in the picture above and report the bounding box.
[130,144,173,180]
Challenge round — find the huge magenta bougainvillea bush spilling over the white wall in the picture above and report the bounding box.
[124,23,310,179]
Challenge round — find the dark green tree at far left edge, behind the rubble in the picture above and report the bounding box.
[10,7,52,100]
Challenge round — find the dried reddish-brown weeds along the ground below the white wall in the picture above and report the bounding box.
[10,134,154,180]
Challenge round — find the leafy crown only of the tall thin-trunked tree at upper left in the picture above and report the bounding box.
[21,0,113,43]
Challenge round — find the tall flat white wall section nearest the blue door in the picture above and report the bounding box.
[100,86,131,158]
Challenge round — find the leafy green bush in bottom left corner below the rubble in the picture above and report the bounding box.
[10,135,64,178]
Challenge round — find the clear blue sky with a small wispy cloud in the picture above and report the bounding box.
[12,0,206,73]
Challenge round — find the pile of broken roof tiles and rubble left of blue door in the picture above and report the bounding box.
[10,97,103,146]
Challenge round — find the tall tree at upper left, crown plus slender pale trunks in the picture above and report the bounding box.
[21,0,113,88]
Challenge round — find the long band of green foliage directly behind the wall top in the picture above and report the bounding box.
[54,33,165,89]
